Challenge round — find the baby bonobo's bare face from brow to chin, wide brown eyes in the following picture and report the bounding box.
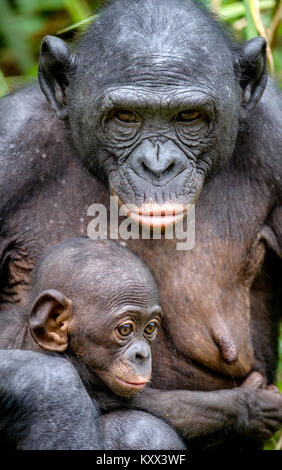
[70,303,161,397]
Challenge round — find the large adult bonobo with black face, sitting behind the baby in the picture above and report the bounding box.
[0,0,282,450]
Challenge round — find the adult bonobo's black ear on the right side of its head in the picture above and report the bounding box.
[238,37,267,111]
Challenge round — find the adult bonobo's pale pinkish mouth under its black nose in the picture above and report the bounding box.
[115,195,188,229]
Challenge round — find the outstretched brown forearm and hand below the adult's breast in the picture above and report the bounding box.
[124,373,282,441]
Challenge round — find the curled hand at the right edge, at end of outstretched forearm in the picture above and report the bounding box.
[239,372,282,439]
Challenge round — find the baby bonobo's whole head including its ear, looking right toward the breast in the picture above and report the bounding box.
[30,239,161,397]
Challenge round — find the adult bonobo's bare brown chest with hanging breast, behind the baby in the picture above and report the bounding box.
[0,149,274,389]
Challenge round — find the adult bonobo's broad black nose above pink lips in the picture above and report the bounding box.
[131,139,188,184]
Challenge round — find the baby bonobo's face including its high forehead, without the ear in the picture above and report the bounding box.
[69,261,161,397]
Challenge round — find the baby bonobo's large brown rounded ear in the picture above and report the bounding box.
[29,289,73,352]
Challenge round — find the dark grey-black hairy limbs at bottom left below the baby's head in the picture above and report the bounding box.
[0,350,185,450]
